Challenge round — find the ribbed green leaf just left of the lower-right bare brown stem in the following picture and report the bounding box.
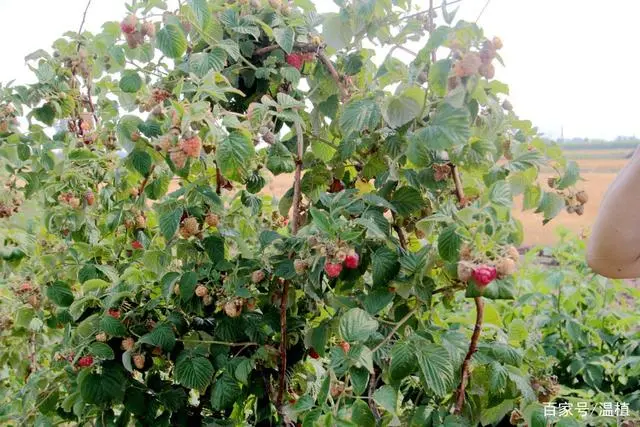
[416,342,453,396]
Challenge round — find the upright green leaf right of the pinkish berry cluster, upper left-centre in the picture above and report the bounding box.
[216,131,255,182]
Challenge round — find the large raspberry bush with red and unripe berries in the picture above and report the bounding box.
[0,0,608,426]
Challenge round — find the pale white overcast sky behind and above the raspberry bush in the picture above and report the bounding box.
[0,0,640,138]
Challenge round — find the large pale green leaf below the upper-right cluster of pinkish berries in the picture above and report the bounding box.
[407,104,471,156]
